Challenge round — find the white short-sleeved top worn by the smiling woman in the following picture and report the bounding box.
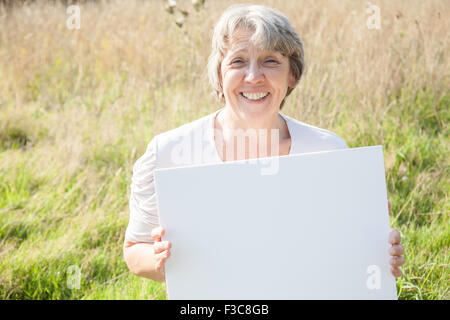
[125,108,347,243]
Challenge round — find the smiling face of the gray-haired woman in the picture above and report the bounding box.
[221,29,295,115]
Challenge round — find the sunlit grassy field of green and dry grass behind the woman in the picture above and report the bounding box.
[0,0,450,299]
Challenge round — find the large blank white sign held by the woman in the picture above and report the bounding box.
[155,146,397,299]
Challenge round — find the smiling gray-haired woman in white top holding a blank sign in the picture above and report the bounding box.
[124,5,404,281]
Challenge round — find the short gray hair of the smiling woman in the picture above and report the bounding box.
[207,4,305,109]
